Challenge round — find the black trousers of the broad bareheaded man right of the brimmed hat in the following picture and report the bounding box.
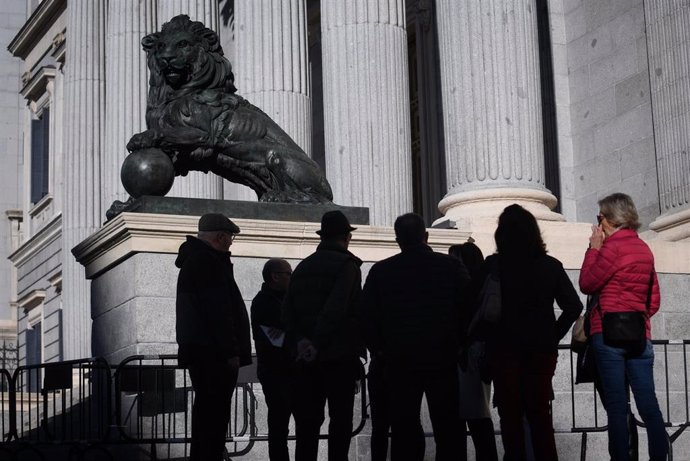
[389,363,464,461]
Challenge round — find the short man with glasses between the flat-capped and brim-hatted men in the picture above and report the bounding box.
[251,259,295,461]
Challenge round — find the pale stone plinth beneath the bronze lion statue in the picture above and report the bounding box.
[73,208,469,363]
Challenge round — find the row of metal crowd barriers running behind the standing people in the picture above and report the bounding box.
[0,340,690,460]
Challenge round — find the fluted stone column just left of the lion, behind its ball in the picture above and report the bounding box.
[102,0,157,210]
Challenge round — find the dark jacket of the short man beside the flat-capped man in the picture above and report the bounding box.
[251,283,292,378]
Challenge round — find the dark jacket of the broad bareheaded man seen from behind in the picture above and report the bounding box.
[362,245,469,369]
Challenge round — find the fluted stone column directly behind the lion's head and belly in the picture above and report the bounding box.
[157,0,223,199]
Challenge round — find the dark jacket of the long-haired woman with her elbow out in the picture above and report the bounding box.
[481,255,582,354]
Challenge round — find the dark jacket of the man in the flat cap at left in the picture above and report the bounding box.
[175,236,252,365]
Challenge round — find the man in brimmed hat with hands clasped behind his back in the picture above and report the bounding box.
[283,211,364,461]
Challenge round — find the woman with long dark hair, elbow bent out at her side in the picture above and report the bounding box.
[480,205,582,461]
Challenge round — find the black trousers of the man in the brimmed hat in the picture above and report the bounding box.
[294,357,361,461]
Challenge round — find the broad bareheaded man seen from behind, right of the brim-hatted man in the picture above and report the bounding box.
[362,213,469,461]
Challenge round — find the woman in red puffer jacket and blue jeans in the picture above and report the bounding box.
[580,193,668,461]
